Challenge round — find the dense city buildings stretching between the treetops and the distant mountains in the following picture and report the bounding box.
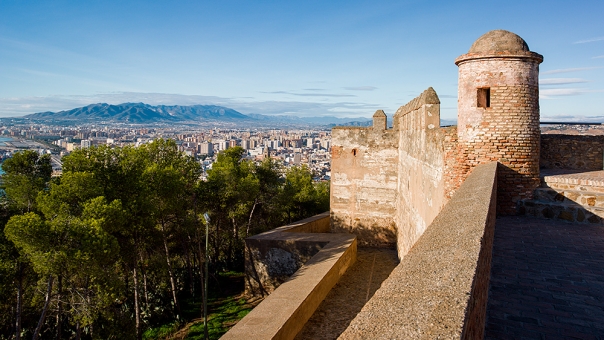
[0,119,331,181]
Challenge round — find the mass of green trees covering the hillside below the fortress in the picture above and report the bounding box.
[0,140,329,339]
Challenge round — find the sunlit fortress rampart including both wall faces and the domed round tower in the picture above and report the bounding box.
[331,30,543,258]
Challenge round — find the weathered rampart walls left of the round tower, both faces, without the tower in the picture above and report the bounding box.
[331,88,455,257]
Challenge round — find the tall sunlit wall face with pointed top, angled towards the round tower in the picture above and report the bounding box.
[394,88,446,258]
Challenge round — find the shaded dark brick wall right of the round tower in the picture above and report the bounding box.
[540,134,604,171]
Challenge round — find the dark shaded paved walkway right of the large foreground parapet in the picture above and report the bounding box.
[486,217,604,339]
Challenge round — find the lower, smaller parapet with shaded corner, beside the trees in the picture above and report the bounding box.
[229,213,357,340]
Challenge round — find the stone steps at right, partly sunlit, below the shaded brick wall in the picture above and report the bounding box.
[517,170,604,225]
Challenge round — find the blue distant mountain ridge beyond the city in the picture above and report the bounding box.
[24,103,250,124]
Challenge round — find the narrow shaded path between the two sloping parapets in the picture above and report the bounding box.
[296,248,398,340]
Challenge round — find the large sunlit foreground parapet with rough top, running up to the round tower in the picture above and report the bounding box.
[340,162,497,339]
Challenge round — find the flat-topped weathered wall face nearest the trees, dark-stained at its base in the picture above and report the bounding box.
[330,127,398,246]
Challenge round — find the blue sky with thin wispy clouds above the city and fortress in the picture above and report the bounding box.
[0,0,604,120]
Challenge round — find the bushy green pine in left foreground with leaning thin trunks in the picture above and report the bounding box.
[5,173,123,338]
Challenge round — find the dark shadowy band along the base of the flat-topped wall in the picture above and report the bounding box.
[331,214,396,248]
